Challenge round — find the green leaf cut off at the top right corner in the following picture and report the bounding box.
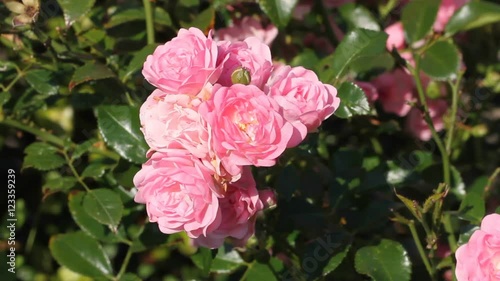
[445,1,500,35]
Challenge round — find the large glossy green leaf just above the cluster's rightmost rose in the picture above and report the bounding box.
[318,28,387,83]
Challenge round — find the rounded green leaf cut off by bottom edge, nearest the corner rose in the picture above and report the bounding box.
[354,239,411,281]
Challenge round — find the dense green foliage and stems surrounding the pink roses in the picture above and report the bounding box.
[0,0,500,281]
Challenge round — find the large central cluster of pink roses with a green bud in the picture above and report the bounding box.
[134,28,340,248]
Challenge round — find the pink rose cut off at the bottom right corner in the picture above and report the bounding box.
[455,214,500,281]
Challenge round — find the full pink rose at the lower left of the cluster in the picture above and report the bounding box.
[134,151,221,238]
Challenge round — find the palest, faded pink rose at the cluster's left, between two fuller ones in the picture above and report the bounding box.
[140,89,209,158]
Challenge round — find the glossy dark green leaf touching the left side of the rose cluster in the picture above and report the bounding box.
[97,105,148,164]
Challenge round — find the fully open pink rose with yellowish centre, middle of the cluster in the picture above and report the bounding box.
[199,84,293,176]
